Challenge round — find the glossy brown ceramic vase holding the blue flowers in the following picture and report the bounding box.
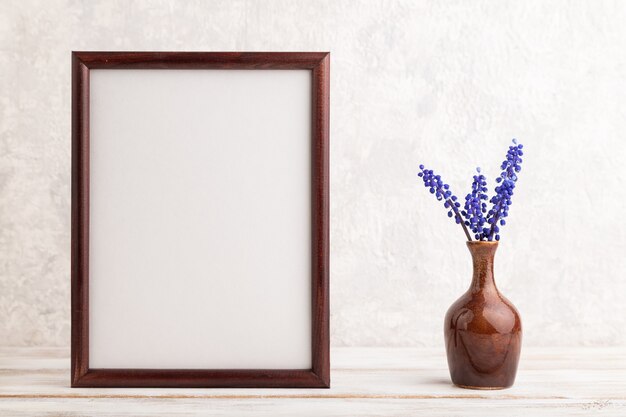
[444,241,522,389]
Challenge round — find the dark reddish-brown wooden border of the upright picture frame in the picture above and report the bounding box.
[71,52,330,388]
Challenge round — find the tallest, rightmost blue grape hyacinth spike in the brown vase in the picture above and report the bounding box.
[485,139,524,240]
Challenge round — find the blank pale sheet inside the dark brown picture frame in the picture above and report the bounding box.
[89,69,312,369]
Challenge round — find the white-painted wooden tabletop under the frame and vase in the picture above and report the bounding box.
[0,347,626,417]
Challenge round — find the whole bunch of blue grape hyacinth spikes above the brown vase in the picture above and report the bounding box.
[417,139,524,242]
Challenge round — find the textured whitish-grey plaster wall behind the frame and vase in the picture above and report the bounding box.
[0,0,626,346]
